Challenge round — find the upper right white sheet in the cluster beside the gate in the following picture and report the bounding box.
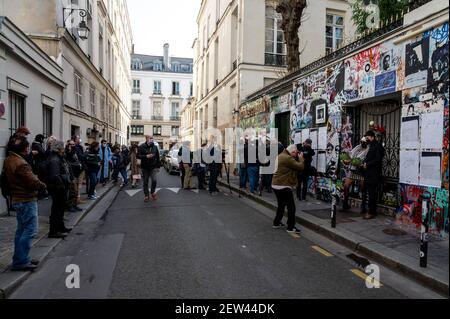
[420,112,444,150]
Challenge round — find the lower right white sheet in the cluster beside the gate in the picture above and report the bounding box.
[419,152,442,188]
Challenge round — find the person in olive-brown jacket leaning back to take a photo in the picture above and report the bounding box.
[272,145,305,233]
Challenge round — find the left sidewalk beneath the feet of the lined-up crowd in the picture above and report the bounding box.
[0,182,115,299]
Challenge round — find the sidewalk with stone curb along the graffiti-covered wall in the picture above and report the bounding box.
[219,176,449,295]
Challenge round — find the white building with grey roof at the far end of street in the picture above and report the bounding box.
[131,44,193,150]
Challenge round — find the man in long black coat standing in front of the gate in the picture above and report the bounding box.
[363,131,384,219]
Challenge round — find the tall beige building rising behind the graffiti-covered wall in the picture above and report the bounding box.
[183,0,355,149]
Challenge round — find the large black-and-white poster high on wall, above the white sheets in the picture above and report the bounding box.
[405,37,430,89]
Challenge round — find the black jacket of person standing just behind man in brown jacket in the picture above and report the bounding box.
[47,153,71,191]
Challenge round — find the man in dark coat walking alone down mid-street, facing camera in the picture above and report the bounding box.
[138,135,161,203]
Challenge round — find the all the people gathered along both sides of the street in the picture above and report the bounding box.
[1,127,384,270]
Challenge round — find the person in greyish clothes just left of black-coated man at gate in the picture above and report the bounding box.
[341,137,369,214]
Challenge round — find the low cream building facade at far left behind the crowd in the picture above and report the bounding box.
[0,16,66,213]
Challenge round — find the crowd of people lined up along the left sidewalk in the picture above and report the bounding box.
[1,127,135,271]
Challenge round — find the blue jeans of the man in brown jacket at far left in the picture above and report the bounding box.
[12,201,38,269]
